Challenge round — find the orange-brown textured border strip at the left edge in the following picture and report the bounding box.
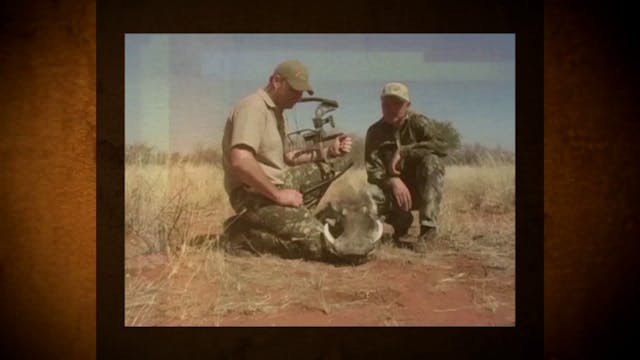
[0,0,96,359]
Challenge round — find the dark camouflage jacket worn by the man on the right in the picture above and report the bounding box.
[365,111,447,187]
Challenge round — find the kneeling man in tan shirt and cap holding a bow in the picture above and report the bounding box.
[222,60,353,259]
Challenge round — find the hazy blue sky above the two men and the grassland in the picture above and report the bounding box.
[125,34,515,151]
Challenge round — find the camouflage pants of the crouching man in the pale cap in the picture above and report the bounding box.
[367,151,444,234]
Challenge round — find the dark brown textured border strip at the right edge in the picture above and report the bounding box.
[544,1,640,359]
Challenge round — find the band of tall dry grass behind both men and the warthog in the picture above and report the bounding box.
[125,152,515,252]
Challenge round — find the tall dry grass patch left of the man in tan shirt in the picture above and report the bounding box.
[125,164,232,253]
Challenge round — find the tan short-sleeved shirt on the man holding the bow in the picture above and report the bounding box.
[222,89,288,194]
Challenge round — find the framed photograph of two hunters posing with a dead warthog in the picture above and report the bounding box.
[122,33,517,327]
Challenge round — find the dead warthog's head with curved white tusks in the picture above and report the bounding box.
[317,203,383,259]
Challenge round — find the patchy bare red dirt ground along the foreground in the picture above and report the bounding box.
[127,248,515,326]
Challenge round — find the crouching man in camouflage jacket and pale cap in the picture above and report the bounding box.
[365,82,446,252]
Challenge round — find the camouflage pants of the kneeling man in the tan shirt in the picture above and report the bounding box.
[225,155,353,260]
